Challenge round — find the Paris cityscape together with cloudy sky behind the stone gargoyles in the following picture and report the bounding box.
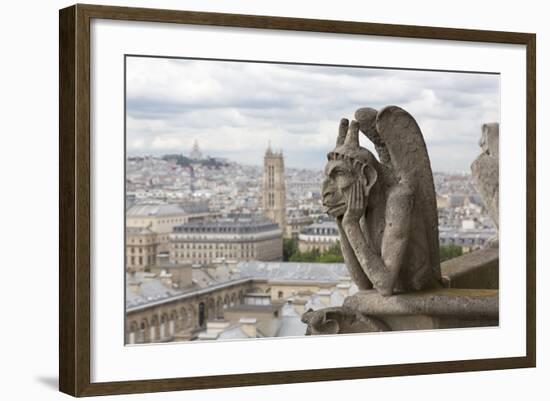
[124,56,499,345]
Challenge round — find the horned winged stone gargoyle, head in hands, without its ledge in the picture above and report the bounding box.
[322,106,441,296]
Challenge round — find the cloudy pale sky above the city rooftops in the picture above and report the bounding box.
[126,57,500,172]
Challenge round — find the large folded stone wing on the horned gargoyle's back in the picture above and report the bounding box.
[356,106,441,278]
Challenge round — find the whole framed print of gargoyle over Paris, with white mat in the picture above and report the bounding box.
[59,5,536,396]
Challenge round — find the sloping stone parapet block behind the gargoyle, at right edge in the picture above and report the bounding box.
[441,248,499,289]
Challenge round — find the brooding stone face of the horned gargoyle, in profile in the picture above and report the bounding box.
[321,160,357,217]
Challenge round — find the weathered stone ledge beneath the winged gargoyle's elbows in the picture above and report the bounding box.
[302,288,498,334]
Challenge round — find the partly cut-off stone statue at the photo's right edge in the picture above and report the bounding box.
[471,123,499,231]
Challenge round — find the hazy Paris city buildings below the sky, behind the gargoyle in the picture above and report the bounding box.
[126,140,496,344]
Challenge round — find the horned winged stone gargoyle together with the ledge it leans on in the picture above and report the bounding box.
[302,106,498,335]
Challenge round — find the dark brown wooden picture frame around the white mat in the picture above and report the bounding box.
[59,5,536,396]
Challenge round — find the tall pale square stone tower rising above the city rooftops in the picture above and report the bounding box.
[262,145,286,233]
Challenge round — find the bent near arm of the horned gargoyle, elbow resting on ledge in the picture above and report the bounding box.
[342,183,413,295]
